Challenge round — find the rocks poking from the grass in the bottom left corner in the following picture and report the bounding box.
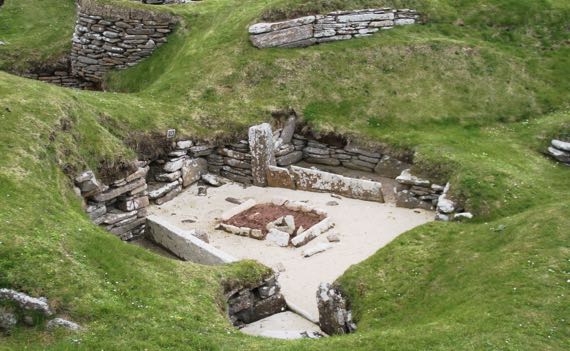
[0,289,81,334]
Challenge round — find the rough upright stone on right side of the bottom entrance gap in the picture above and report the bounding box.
[317,283,356,335]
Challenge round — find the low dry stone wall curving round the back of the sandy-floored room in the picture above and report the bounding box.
[71,115,468,240]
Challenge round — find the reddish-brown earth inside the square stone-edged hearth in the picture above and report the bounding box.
[224,204,325,234]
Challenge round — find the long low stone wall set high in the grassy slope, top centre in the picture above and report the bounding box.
[249,8,420,48]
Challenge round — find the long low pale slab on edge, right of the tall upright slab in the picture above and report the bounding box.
[291,166,384,202]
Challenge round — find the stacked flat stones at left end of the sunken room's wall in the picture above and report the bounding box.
[75,161,149,240]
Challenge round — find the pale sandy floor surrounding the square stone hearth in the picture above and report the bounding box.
[150,184,434,320]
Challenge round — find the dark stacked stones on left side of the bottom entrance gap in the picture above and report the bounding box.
[226,276,287,327]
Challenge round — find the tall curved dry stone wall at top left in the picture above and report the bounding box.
[71,0,176,82]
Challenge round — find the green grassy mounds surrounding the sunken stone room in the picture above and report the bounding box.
[0,0,570,350]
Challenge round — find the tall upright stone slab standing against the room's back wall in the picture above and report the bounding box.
[249,123,276,186]
